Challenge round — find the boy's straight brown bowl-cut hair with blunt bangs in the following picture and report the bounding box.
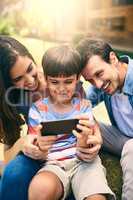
[42,45,81,77]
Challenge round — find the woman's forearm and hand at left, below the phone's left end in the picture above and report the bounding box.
[4,134,57,163]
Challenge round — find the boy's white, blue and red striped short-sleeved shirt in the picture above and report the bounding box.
[28,98,92,161]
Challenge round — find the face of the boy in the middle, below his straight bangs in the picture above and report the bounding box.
[47,74,78,104]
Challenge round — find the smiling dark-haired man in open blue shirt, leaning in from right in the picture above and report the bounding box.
[77,38,133,200]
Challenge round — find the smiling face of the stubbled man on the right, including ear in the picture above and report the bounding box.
[82,55,120,94]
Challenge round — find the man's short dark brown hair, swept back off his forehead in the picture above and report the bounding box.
[76,37,119,69]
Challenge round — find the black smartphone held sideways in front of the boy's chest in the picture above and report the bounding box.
[41,119,79,136]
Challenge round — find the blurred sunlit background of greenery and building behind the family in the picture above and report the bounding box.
[0,0,133,159]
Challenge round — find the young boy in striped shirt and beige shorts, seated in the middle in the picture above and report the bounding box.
[29,45,115,200]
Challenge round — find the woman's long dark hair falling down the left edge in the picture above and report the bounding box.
[0,36,34,146]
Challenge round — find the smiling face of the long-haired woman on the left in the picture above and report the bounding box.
[10,56,39,91]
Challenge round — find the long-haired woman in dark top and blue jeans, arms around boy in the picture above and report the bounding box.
[0,36,101,200]
